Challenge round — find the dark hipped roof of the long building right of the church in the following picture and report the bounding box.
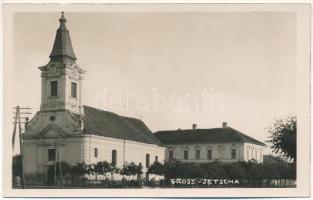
[155,127,265,146]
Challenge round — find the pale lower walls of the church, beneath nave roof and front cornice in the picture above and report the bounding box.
[24,133,165,183]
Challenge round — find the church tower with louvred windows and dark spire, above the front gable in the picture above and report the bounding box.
[39,12,85,114]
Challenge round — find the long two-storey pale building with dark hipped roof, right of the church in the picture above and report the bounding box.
[155,122,265,162]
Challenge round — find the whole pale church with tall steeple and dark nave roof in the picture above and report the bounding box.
[23,13,165,184]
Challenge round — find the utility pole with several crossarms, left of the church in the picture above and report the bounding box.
[12,106,31,189]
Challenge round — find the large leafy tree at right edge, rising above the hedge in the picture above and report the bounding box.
[267,116,297,162]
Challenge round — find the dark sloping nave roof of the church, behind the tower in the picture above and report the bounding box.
[83,106,162,146]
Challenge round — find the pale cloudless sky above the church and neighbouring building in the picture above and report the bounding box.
[6,12,297,153]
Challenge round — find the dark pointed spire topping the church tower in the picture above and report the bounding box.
[50,12,76,64]
